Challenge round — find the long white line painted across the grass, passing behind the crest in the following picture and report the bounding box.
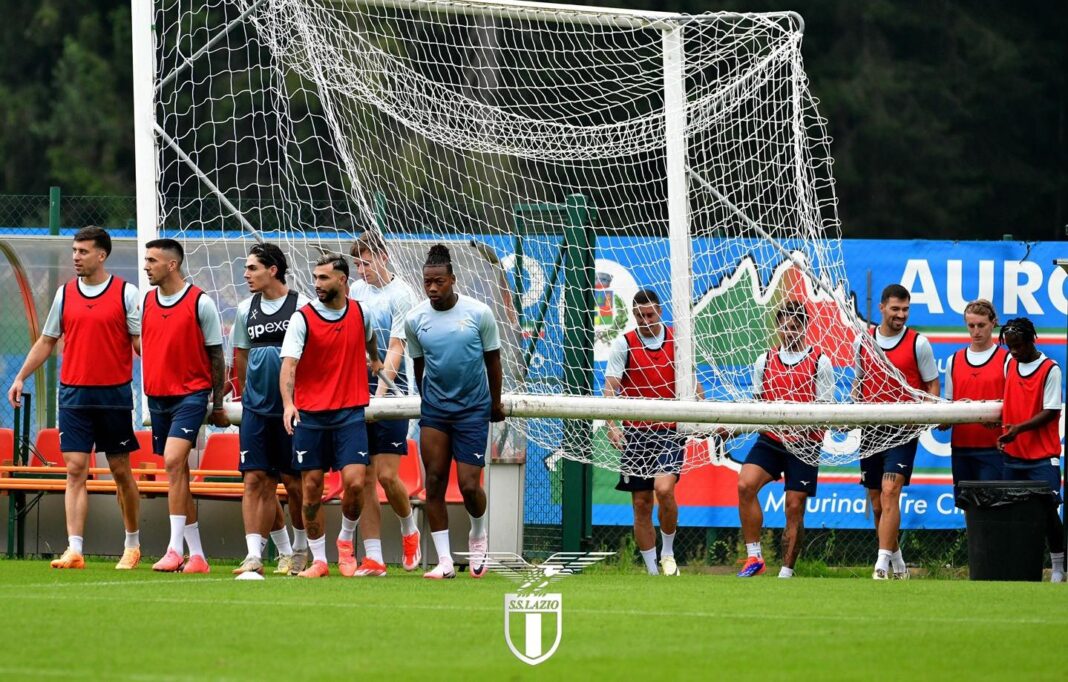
[4,594,1068,625]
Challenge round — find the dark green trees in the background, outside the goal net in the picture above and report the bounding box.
[0,0,1068,239]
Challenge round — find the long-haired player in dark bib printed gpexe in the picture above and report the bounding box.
[232,243,309,575]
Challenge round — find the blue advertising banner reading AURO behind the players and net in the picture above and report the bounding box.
[504,237,1068,529]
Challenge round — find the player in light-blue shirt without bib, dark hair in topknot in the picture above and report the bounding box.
[405,244,504,580]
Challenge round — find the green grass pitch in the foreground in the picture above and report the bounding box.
[0,560,1068,682]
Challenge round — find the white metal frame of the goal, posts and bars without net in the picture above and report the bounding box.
[131,0,1001,427]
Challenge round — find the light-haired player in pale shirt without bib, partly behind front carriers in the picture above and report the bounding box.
[349,232,422,577]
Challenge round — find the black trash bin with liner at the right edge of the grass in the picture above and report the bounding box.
[959,480,1053,582]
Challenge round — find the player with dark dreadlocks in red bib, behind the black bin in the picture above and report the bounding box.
[998,317,1065,583]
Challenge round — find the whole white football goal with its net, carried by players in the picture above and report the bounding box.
[132,0,1000,474]
